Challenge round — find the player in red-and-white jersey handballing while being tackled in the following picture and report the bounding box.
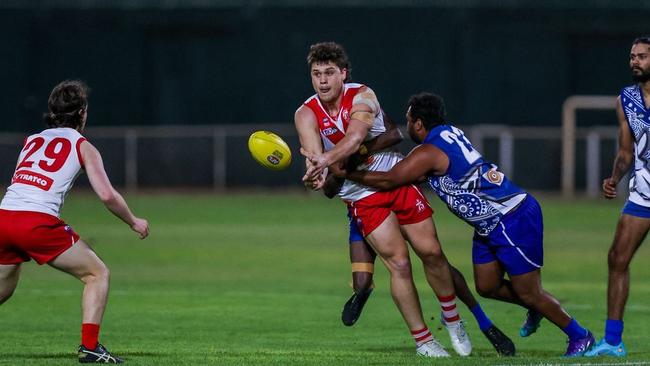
[295,42,471,357]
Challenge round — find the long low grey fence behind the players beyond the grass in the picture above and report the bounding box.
[0,123,617,192]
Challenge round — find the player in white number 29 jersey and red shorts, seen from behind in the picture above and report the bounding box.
[0,80,149,363]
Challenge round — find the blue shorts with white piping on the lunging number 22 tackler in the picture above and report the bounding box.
[472,194,544,275]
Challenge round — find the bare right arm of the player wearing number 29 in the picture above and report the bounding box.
[79,141,149,239]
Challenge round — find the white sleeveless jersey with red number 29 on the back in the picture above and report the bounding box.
[0,127,85,217]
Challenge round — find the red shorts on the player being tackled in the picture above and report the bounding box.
[348,185,433,237]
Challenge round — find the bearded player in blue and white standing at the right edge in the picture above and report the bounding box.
[587,37,650,357]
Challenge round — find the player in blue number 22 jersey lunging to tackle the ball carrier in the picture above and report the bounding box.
[336,93,594,357]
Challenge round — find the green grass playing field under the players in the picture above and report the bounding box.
[0,192,650,365]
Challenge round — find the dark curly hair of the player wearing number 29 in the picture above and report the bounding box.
[43,80,89,129]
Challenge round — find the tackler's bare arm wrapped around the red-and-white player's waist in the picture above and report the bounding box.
[346,144,449,190]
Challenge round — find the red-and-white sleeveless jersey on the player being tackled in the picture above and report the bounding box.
[304,83,404,202]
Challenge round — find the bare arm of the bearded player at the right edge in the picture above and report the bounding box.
[603,96,634,199]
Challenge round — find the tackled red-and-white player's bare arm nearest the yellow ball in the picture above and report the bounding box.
[294,105,325,189]
